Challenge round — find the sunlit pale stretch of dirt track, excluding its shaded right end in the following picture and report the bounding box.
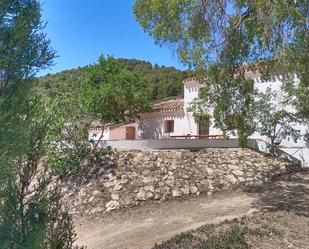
[76,193,255,249]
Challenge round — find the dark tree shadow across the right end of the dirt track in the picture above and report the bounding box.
[245,172,309,217]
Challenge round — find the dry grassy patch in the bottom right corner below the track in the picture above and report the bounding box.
[153,211,309,249]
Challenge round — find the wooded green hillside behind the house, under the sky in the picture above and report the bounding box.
[40,58,193,100]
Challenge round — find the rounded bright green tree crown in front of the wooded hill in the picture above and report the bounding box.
[81,56,151,124]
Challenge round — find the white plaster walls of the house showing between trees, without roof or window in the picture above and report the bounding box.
[139,77,309,164]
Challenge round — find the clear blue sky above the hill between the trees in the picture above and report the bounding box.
[41,0,184,75]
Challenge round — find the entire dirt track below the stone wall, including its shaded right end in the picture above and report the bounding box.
[75,171,309,249]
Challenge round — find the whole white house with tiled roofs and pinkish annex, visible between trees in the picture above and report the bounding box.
[90,75,309,163]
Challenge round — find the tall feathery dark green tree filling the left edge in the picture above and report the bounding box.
[0,0,82,249]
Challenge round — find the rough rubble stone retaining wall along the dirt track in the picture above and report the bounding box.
[64,148,291,215]
